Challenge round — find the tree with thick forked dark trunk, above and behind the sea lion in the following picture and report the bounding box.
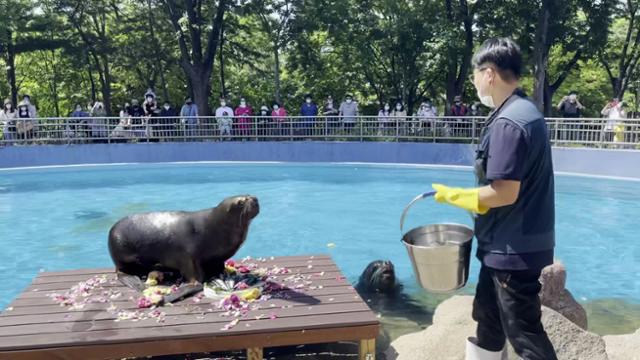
[164,0,228,115]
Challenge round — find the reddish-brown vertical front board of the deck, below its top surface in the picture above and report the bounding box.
[0,325,379,360]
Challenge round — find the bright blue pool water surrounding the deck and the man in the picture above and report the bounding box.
[0,164,640,309]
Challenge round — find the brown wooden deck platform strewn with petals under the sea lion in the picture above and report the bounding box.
[0,255,379,360]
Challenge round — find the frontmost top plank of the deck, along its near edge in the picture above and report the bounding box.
[0,309,379,351]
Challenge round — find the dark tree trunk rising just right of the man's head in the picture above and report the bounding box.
[533,1,551,111]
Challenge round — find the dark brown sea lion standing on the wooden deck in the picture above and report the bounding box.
[109,195,260,303]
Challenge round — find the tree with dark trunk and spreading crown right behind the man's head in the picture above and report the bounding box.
[480,0,616,116]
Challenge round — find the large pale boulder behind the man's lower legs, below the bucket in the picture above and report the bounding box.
[385,296,607,360]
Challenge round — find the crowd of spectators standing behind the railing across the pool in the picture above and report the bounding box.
[0,89,627,143]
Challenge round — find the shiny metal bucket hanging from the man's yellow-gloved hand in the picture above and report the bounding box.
[400,192,473,293]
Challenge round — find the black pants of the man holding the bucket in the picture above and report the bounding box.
[472,265,557,360]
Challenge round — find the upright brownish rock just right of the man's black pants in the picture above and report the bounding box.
[540,261,587,330]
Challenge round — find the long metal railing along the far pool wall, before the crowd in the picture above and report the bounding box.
[0,116,640,149]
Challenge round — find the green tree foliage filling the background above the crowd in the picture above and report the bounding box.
[0,0,640,116]
